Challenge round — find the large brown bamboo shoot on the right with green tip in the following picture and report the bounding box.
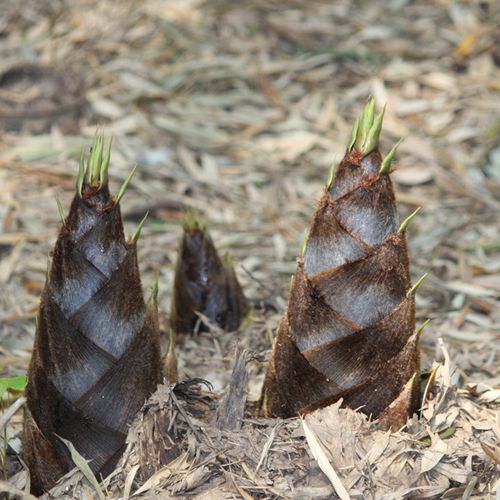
[263,101,419,425]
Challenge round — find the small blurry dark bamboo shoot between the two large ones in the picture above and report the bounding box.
[170,221,248,333]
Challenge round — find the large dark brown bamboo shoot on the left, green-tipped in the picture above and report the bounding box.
[24,138,161,493]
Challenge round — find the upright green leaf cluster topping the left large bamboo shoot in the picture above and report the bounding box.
[77,129,112,196]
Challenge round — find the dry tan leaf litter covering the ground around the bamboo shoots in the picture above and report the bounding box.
[0,0,500,499]
